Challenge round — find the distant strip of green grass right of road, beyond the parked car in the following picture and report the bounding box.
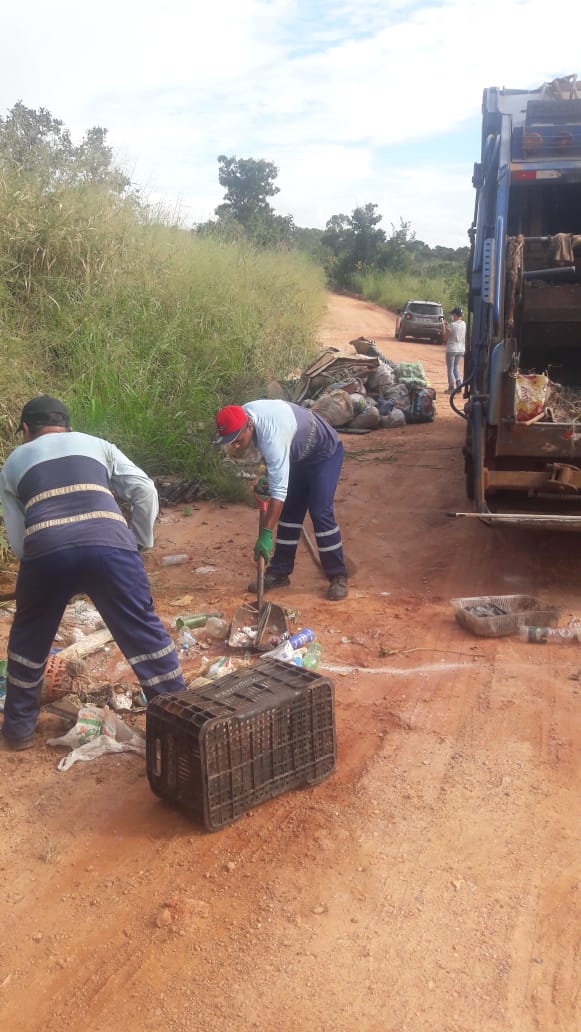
[353,266,467,312]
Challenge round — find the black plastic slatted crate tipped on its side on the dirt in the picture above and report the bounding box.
[147,659,336,831]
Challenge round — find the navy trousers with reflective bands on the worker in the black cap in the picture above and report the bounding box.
[2,547,186,739]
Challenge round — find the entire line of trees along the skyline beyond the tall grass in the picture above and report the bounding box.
[0,100,469,289]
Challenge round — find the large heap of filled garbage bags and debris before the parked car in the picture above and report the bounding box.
[290,336,435,432]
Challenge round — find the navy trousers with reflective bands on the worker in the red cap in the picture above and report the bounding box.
[268,441,347,578]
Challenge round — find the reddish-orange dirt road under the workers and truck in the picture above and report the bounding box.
[0,297,581,1032]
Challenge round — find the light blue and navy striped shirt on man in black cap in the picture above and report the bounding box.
[0,431,159,561]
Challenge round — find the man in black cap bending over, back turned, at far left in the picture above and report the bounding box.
[0,394,186,750]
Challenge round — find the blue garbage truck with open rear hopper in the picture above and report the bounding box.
[451,75,581,530]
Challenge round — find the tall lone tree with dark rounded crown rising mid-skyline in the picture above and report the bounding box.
[216,154,281,226]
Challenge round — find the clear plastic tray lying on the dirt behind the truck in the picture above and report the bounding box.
[452,594,560,638]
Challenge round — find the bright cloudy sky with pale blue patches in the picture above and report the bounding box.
[0,0,581,248]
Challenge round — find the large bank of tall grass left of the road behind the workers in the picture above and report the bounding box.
[0,175,324,494]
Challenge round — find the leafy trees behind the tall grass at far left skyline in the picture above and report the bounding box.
[0,100,130,194]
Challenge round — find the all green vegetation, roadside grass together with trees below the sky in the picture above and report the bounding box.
[0,101,467,551]
